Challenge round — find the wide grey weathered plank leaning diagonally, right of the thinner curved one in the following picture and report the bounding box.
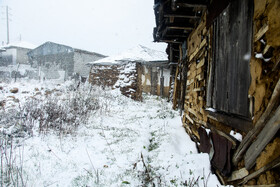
[245,106,280,170]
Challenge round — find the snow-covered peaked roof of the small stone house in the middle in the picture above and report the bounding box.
[88,45,167,65]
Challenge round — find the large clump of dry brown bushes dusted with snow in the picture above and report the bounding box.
[24,85,100,134]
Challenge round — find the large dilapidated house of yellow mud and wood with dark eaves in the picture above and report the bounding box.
[154,0,280,186]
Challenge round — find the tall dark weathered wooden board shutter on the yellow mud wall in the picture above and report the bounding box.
[208,0,253,118]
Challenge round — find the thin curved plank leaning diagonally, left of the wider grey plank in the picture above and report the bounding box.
[232,79,280,165]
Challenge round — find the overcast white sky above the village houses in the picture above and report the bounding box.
[0,0,166,55]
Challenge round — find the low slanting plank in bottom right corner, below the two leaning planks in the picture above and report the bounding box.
[239,157,280,185]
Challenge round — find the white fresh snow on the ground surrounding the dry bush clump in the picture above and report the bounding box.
[0,81,226,187]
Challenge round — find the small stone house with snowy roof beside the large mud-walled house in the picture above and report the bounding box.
[89,45,170,100]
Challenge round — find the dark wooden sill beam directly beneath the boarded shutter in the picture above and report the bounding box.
[207,111,252,132]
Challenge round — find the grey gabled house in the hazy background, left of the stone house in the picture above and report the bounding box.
[27,42,106,80]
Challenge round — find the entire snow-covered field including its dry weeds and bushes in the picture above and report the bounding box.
[0,81,221,187]
